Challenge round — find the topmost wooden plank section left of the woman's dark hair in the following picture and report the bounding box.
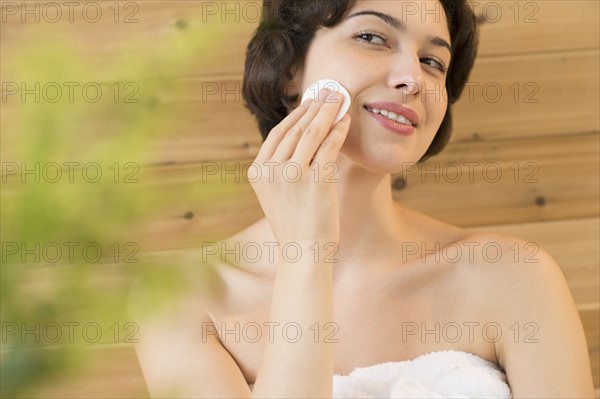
[0,0,254,82]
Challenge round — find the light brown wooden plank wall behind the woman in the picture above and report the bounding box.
[1,0,600,397]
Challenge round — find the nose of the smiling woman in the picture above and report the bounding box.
[387,52,424,96]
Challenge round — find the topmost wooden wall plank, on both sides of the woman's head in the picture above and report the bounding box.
[0,0,599,80]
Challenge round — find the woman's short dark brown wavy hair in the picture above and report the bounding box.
[242,0,479,162]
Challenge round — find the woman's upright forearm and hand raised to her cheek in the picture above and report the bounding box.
[249,89,350,398]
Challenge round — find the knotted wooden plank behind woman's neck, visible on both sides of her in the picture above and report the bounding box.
[78,135,599,250]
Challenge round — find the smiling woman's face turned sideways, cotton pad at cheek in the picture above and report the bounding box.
[294,0,451,173]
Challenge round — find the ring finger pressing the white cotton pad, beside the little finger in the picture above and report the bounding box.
[292,92,344,166]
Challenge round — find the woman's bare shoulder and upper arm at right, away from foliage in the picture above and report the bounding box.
[465,232,594,398]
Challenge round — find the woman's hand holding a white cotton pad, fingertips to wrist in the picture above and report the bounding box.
[248,91,350,245]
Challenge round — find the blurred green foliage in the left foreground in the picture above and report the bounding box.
[0,8,246,397]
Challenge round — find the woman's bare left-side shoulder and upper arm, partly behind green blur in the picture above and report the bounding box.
[129,248,250,397]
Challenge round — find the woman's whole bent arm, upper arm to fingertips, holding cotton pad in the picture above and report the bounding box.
[130,89,350,398]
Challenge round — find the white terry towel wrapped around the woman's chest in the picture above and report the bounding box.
[333,350,512,399]
